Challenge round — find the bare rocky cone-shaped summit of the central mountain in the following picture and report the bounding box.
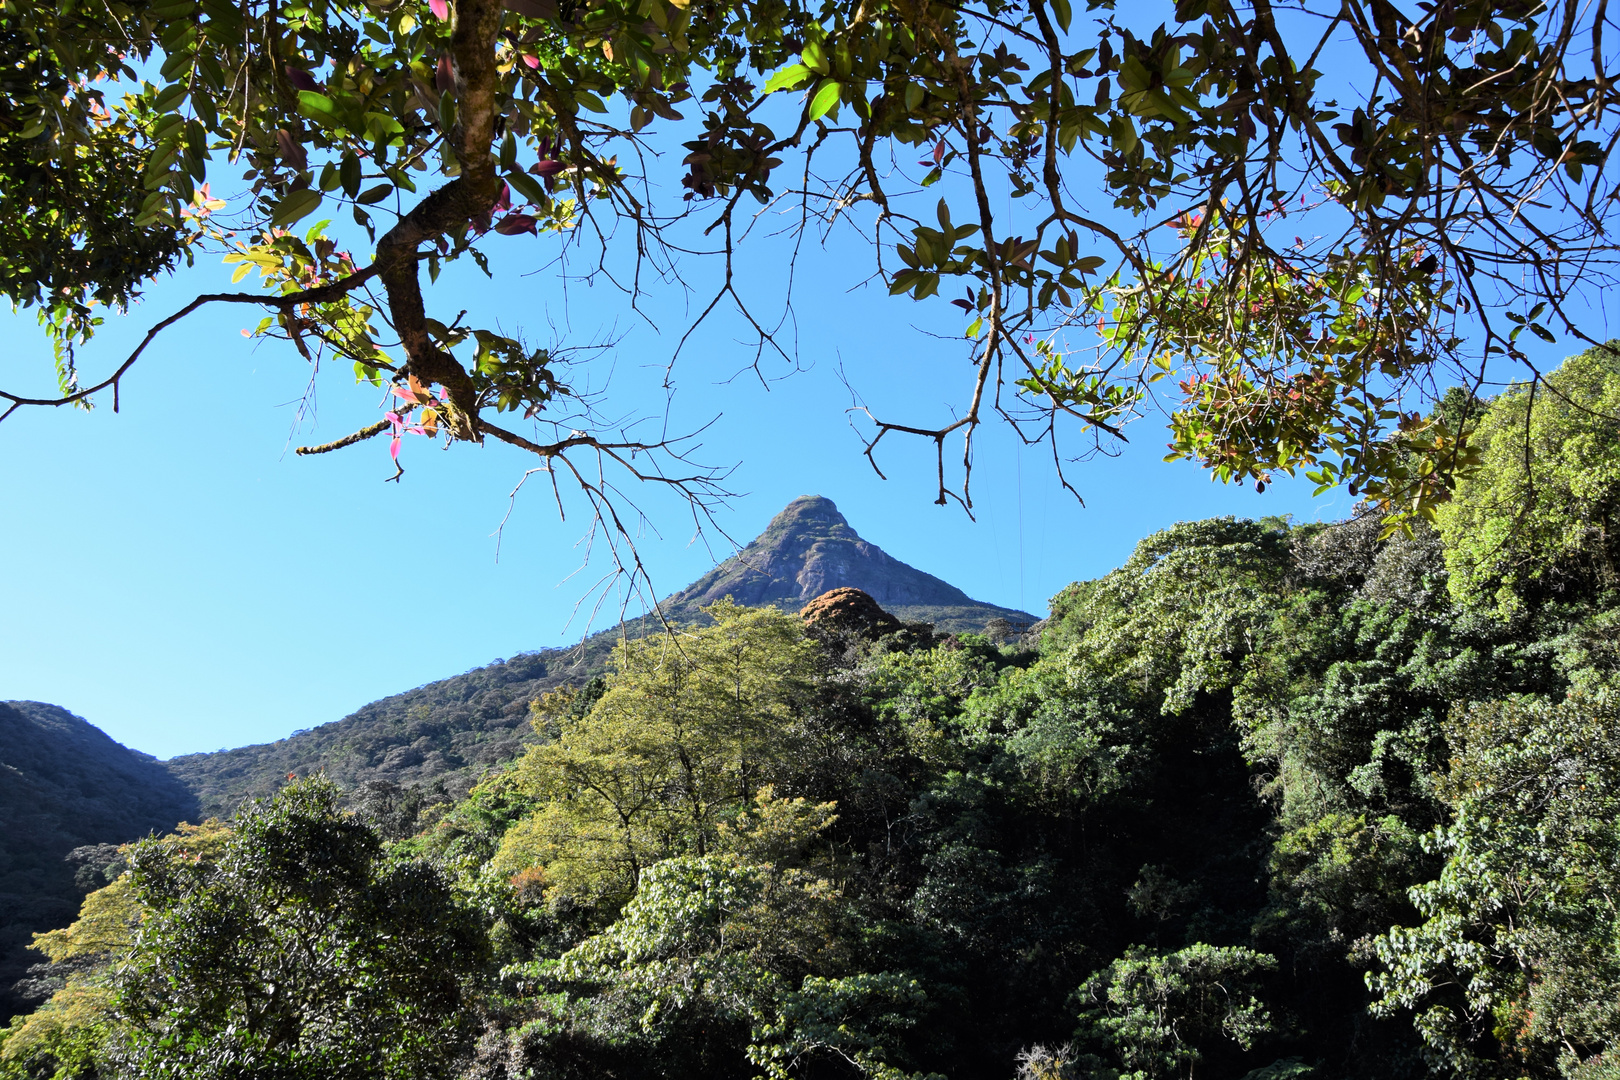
[666,495,1035,631]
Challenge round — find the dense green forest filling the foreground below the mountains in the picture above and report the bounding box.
[0,348,1620,1080]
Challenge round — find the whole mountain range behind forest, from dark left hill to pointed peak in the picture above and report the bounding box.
[0,495,1035,1012]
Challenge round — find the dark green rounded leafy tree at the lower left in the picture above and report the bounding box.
[115,780,481,1077]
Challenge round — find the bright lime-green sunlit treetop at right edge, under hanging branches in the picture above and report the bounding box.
[1439,345,1620,615]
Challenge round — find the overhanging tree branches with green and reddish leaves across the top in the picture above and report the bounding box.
[0,0,1617,537]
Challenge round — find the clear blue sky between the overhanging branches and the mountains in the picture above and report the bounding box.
[0,65,1562,756]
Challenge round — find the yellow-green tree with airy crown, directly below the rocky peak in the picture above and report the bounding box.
[496,602,813,908]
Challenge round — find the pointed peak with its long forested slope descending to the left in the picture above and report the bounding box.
[168,495,1035,816]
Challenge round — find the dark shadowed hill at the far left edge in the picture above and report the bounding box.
[0,701,199,1023]
